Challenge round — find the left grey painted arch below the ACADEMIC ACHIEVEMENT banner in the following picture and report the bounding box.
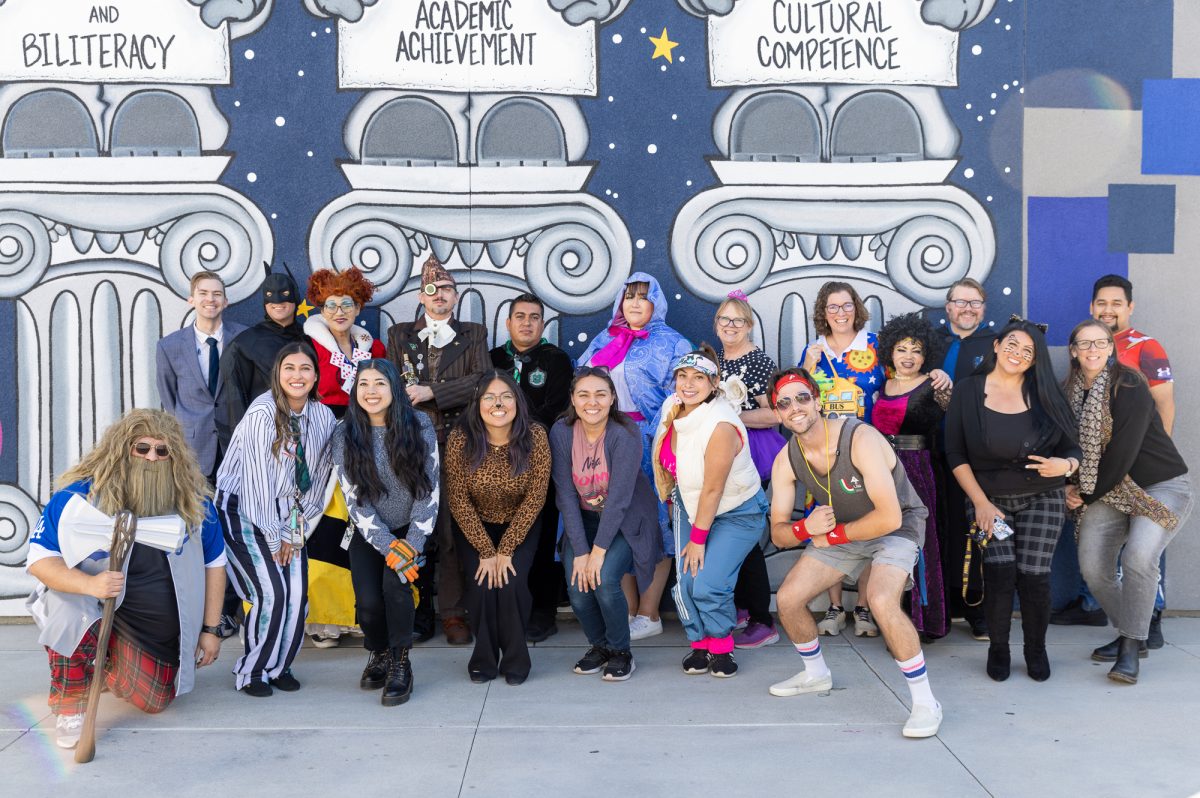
[362,97,458,167]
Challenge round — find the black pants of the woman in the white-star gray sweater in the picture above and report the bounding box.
[349,527,425,652]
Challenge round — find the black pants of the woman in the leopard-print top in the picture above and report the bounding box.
[455,521,541,679]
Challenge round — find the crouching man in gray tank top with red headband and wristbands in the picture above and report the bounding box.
[769,368,942,737]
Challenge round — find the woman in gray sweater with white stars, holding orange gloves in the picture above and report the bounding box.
[331,359,438,707]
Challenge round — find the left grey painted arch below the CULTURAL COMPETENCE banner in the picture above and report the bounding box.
[730,91,821,163]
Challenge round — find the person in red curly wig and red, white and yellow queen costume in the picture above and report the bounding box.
[304,266,385,648]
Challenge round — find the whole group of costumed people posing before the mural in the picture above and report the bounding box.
[29,258,1192,746]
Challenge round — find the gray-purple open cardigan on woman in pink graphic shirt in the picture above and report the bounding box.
[550,420,662,590]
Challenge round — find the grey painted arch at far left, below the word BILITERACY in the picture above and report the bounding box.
[0,89,100,158]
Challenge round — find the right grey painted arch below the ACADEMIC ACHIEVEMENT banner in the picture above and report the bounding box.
[476,97,566,167]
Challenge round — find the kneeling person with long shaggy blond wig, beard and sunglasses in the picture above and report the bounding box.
[26,410,226,748]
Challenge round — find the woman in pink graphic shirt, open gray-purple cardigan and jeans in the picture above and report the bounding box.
[550,366,662,682]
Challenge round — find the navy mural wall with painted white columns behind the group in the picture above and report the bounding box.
[0,0,1200,611]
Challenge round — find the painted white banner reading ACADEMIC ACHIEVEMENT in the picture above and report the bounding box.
[337,0,596,96]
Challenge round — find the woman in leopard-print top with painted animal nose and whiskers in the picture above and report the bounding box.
[445,370,550,684]
